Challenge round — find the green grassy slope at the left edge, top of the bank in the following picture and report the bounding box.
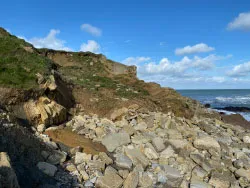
[0,28,52,89]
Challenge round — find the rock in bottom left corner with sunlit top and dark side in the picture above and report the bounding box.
[0,152,19,188]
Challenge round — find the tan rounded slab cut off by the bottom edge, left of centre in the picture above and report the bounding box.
[95,170,123,188]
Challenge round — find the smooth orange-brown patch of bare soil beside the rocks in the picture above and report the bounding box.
[45,128,107,155]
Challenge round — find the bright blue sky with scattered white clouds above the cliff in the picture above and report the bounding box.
[0,0,250,89]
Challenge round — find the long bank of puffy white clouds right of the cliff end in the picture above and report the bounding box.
[138,55,231,77]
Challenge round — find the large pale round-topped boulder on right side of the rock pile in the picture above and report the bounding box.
[194,136,221,155]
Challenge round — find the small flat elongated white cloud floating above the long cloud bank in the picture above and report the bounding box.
[175,43,214,55]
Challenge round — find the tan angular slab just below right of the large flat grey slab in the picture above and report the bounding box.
[125,148,149,168]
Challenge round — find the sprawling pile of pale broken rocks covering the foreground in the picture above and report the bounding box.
[33,106,250,188]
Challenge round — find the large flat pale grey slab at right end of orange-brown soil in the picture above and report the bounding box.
[102,132,131,152]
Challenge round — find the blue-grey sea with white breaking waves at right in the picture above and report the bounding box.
[177,89,250,121]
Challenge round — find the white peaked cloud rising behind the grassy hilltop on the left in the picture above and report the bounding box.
[27,29,72,51]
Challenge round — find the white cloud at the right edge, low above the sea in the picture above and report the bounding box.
[227,61,250,77]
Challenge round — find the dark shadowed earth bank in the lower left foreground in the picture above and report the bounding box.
[0,112,75,188]
